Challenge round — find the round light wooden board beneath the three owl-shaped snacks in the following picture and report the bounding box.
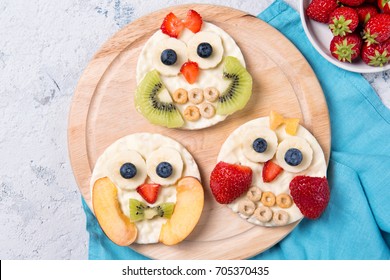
[68,5,330,259]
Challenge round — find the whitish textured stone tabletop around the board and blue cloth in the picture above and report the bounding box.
[0,0,390,259]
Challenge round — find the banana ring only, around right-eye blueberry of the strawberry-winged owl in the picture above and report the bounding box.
[276,136,313,173]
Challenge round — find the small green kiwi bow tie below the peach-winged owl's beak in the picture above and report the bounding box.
[129,198,175,222]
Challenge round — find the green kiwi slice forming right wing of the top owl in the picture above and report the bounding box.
[217,56,252,115]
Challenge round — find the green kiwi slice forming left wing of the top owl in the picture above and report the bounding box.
[135,70,184,128]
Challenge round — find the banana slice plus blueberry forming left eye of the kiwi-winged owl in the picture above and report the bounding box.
[152,38,188,76]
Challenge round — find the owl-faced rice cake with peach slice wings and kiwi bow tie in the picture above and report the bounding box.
[90,133,204,246]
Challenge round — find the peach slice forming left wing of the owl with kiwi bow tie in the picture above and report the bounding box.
[92,177,137,246]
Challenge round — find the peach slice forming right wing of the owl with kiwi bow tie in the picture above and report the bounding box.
[159,177,204,245]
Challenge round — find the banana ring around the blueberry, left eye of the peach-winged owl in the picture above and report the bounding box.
[107,150,147,190]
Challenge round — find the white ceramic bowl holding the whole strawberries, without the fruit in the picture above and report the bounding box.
[299,0,390,73]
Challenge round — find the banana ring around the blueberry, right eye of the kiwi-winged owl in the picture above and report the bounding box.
[187,31,224,69]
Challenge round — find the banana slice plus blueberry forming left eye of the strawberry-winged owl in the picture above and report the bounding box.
[242,126,278,162]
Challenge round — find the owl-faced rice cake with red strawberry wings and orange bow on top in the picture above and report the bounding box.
[210,112,330,227]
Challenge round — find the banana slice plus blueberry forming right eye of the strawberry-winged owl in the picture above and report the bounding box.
[276,136,313,173]
